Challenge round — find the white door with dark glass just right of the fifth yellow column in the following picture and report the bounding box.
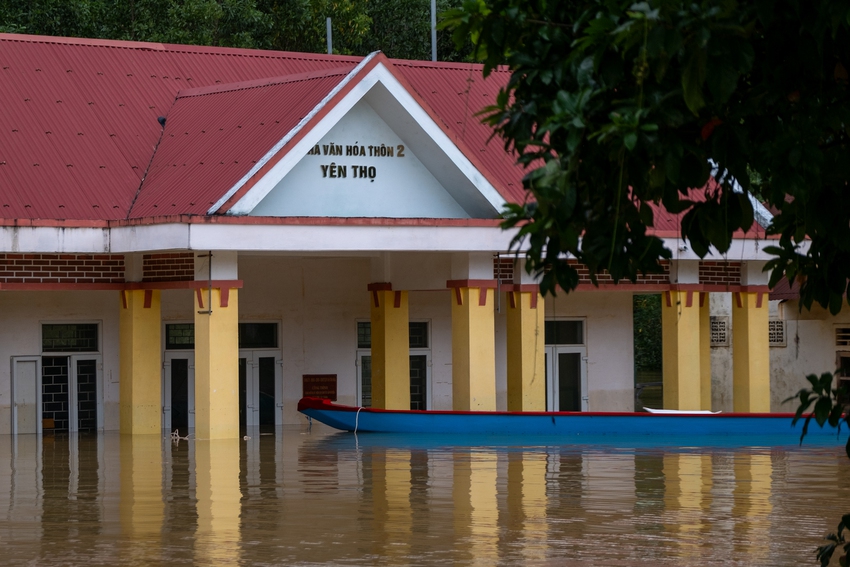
[546,345,588,411]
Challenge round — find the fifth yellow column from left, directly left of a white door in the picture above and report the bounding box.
[507,284,546,411]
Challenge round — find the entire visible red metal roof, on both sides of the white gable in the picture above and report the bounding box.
[0,34,744,241]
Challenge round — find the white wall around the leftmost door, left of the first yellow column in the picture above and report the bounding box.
[0,291,120,434]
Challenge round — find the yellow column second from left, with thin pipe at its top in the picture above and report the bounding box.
[195,288,239,439]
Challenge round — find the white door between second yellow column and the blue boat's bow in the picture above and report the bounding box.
[239,349,283,427]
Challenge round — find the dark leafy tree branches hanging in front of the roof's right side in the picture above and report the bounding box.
[446,0,850,313]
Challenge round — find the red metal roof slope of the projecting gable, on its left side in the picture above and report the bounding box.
[129,68,349,218]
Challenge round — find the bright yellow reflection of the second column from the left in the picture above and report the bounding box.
[195,439,242,565]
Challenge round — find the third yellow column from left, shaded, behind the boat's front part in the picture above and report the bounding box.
[368,283,410,410]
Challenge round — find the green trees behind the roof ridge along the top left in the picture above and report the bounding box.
[0,0,470,61]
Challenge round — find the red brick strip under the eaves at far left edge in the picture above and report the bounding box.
[0,254,124,283]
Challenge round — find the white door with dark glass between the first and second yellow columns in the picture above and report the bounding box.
[162,351,195,437]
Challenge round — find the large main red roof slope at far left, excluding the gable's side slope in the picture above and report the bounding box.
[0,34,360,220]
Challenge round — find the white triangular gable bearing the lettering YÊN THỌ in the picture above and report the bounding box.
[214,54,505,218]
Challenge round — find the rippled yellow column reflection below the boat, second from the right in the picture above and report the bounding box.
[664,453,713,564]
